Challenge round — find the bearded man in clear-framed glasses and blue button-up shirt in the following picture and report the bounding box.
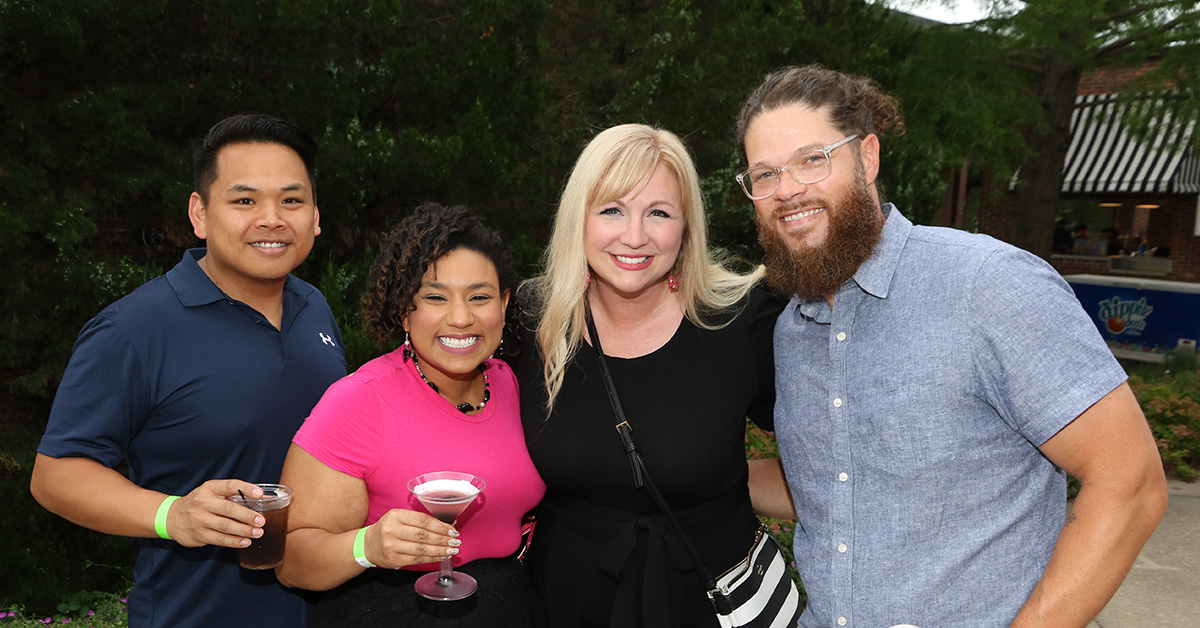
[738,66,1166,628]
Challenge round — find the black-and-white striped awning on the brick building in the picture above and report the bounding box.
[1062,94,1200,195]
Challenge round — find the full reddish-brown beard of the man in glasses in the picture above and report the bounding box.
[756,166,883,300]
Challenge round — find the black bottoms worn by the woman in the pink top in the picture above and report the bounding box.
[308,557,534,628]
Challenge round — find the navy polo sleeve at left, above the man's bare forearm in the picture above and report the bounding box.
[37,316,154,468]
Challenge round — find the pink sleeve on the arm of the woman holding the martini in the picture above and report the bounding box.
[292,376,384,479]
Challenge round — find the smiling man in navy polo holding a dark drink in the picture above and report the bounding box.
[30,115,346,628]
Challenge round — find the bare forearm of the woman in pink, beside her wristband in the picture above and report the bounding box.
[275,528,366,591]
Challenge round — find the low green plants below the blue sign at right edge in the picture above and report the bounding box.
[1129,351,1200,482]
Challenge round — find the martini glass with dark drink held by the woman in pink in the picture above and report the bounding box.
[408,471,484,602]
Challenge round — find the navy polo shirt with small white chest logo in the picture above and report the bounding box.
[37,249,346,628]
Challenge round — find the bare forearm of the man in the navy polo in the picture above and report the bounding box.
[29,454,167,538]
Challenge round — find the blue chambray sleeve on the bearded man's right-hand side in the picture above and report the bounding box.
[965,249,1127,445]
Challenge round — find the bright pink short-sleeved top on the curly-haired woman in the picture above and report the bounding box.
[293,349,546,570]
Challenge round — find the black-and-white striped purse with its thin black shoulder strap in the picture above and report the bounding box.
[587,311,803,628]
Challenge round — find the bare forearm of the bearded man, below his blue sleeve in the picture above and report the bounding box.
[1013,468,1166,628]
